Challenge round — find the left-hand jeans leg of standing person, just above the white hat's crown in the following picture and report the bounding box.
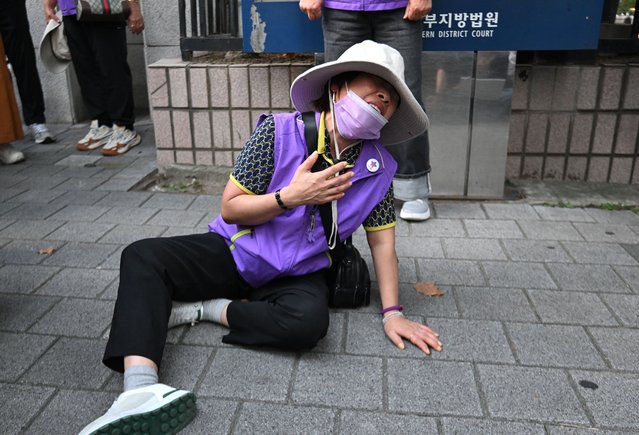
[322,8,373,62]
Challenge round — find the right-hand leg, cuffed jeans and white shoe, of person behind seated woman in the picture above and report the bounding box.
[372,9,430,220]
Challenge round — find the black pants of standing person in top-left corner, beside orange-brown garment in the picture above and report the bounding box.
[0,0,45,125]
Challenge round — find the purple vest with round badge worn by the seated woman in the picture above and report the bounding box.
[209,112,397,287]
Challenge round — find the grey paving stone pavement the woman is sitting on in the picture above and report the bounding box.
[0,118,639,435]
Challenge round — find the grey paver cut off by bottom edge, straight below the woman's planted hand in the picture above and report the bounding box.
[342,410,437,435]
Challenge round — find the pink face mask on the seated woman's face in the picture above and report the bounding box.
[329,85,388,140]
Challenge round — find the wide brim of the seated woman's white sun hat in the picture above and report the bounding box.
[291,60,428,145]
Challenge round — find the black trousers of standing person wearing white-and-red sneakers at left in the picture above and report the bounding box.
[62,15,135,130]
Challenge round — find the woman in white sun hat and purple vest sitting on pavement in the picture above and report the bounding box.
[81,41,442,435]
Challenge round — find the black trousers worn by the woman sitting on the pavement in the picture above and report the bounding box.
[103,233,328,372]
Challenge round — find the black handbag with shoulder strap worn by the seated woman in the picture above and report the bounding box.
[302,112,371,308]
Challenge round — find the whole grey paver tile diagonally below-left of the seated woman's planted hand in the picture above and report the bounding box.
[292,353,382,410]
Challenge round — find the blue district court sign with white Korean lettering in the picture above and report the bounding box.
[242,0,603,53]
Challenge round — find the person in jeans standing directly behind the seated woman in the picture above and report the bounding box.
[299,0,432,221]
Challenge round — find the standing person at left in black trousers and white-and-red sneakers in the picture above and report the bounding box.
[44,0,144,156]
